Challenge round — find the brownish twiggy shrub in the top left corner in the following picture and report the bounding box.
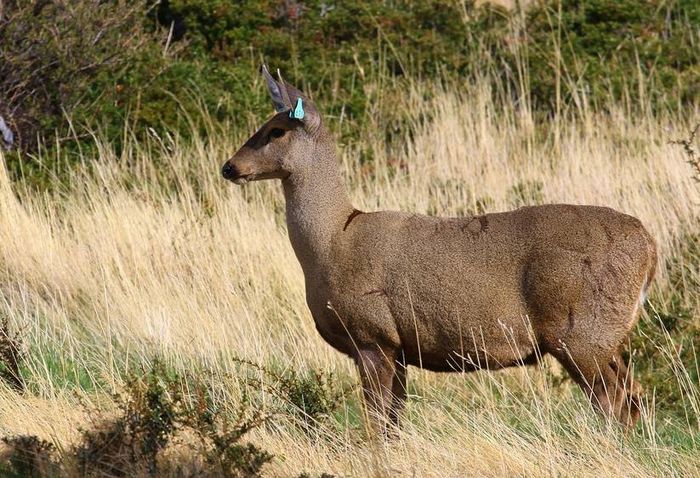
[0,0,154,151]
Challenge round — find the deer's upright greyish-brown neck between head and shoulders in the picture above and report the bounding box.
[282,144,354,274]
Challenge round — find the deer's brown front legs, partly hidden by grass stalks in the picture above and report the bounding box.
[355,347,396,432]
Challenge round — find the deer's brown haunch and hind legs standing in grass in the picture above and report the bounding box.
[526,248,645,429]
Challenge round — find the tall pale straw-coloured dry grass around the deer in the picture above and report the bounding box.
[0,79,700,476]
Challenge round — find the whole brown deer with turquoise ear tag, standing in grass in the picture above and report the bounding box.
[221,65,657,430]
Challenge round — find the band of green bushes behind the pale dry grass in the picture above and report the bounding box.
[0,0,700,186]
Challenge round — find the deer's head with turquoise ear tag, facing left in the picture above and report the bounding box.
[221,65,321,184]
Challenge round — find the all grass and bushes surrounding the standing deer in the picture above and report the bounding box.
[0,0,700,477]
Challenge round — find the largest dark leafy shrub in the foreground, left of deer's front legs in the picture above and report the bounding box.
[73,361,272,477]
